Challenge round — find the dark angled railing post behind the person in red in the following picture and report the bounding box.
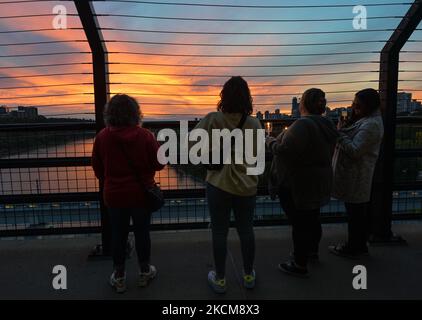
[74,0,111,255]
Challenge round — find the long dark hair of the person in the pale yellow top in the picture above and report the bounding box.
[217,76,253,115]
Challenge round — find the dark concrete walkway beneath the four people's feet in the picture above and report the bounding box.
[0,222,422,300]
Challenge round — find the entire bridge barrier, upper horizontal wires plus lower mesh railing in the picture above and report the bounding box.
[0,0,422,248]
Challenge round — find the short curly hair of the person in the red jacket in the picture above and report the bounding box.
[104,94,142,127]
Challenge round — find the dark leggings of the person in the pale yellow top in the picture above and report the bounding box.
[207,184,256,278]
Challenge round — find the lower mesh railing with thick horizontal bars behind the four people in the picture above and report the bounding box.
[0,117,422,236]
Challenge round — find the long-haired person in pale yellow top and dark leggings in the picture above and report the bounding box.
[196,77,261,293]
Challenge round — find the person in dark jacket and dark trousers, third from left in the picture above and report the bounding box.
[267,88,338,276]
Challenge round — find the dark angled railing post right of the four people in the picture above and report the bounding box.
[371,0,422,243]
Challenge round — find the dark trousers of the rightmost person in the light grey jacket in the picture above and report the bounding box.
[344,202,369,252]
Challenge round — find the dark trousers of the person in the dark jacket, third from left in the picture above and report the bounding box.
[279,188,322,267]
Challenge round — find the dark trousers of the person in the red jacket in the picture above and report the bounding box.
[108,208,151,271]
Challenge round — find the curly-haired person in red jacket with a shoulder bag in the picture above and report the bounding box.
[92,94,164,292]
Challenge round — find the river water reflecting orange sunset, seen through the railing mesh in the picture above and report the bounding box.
[0,138,204,195]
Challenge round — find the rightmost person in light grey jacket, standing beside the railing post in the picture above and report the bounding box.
[329,89,384,258]
